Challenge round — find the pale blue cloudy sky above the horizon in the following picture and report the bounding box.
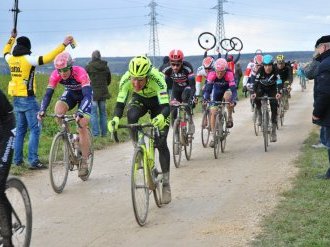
[0,0,330,57]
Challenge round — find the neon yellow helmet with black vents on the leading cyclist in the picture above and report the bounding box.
[128,56,152,77]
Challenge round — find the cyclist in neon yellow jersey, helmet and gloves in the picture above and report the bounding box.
[108,56,171,203]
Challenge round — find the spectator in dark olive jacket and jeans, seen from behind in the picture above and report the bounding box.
[86,50,111,137]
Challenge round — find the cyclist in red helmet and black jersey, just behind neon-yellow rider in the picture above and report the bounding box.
[162,50,196,135]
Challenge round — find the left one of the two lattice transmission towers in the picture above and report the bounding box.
[148,0,160,67]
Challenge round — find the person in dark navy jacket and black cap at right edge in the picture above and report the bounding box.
[312,35,330,179]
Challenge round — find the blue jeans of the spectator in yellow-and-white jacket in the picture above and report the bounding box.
[13,96,40,166]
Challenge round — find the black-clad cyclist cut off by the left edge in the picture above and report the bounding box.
[0,90,16,247]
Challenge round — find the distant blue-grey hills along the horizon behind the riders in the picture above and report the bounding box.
[0,51,313,75]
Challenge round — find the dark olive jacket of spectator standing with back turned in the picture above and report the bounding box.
[86,58,111,101]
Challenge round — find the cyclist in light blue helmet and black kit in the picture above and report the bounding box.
[251,55,282,142]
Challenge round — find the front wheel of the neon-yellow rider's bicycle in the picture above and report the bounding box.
[131,149,149,226]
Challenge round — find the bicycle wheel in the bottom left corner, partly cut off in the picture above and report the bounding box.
[6,177,32,247]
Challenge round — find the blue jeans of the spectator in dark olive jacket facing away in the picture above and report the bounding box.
[91,100,107,136]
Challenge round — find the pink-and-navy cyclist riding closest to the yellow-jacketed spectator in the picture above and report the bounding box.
[38,52,93,177]
